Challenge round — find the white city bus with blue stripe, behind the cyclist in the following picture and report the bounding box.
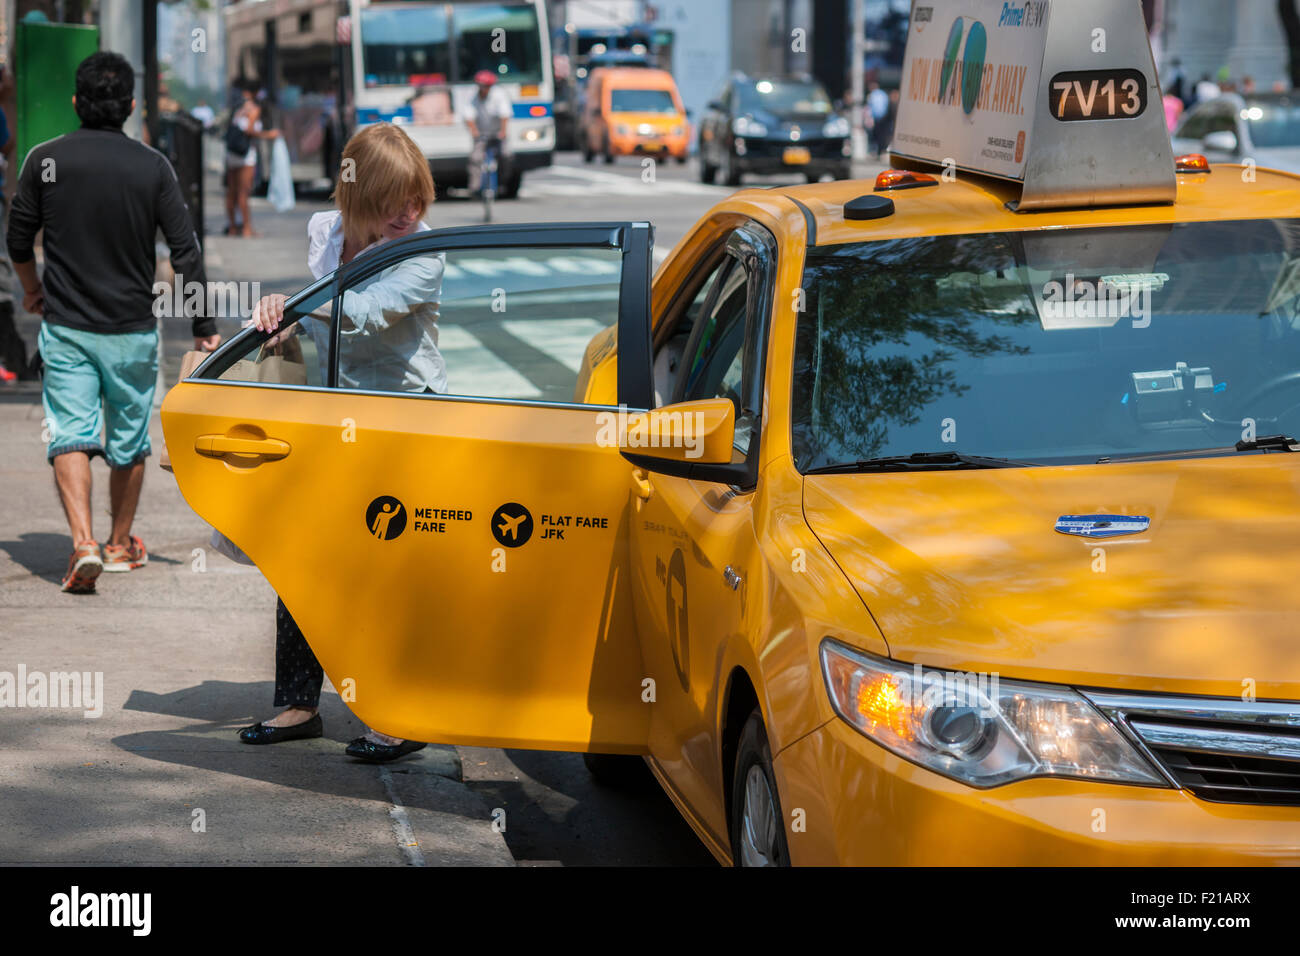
[350,0,555,196]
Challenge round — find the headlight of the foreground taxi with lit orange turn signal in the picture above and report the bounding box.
[822,639,1169,787]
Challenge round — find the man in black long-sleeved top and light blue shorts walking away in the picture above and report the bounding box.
[7,51,221,593]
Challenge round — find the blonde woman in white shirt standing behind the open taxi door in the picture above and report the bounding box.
[239,124,447,762]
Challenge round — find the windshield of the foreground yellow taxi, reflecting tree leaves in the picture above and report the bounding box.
[792,220,1300,472]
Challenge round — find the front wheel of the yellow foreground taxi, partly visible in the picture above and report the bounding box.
[731,708,790,866]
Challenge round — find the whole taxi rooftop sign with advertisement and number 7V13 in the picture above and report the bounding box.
[891,0,1174,209]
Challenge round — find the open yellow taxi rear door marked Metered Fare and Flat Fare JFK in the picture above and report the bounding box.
[163,222,651,753]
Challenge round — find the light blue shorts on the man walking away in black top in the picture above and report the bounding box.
[38,323,159,468]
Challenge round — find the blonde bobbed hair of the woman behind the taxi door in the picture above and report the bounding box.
[334,122,433,246]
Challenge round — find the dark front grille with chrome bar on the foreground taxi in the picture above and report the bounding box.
[1087,692,1300,806]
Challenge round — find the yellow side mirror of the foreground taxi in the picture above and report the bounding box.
[610,398,736,464]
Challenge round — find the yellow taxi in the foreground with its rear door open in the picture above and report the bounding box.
[163,0,1300,865]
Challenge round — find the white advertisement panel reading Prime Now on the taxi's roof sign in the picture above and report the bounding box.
[893,0,1048,181]
